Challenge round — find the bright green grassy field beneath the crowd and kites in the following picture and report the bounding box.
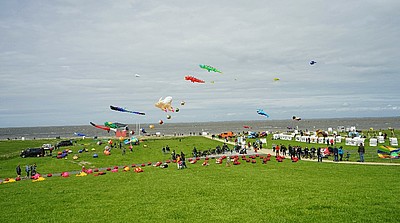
[0,137,400,222]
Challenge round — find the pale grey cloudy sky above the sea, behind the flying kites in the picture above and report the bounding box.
[0,0,400,127]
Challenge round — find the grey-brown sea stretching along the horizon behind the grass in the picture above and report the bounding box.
[0,117,400,139]
